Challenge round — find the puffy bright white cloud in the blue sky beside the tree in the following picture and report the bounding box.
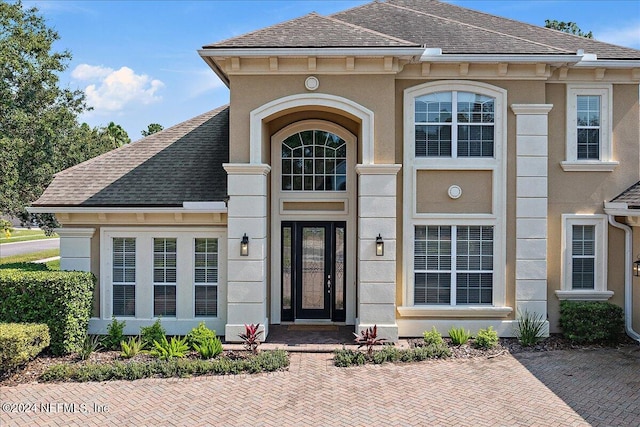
[71,64,164,113]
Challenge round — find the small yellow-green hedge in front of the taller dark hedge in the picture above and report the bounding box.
[0,323,49,372]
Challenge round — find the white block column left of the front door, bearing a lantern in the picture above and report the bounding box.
[223,163,271,341]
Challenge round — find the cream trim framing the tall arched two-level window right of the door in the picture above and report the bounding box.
[398,80,512,317]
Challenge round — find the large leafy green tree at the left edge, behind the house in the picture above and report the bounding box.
[0,1,129,229]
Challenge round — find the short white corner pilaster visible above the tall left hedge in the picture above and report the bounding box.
[55,228,96,271]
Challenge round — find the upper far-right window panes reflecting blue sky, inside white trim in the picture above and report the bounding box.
[576,95,600,160]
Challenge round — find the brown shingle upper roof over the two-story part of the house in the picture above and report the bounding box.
[204,0,640,59]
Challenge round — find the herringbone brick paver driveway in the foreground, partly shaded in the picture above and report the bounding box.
[0,347,640,427]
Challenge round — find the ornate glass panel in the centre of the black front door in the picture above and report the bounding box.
[302,227,325,310]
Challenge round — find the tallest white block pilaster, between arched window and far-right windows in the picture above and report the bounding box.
[511,104,553,333]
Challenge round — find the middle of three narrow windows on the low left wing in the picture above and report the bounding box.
[153,238,177,316]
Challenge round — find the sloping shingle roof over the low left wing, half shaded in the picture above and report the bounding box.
[33,107,229,207]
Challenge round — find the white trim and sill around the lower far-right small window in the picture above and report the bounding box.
[556,214,613,301]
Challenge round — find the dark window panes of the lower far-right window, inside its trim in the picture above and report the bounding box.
[571,225,596,289]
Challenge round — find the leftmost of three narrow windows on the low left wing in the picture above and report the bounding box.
[112,237,136,316]
